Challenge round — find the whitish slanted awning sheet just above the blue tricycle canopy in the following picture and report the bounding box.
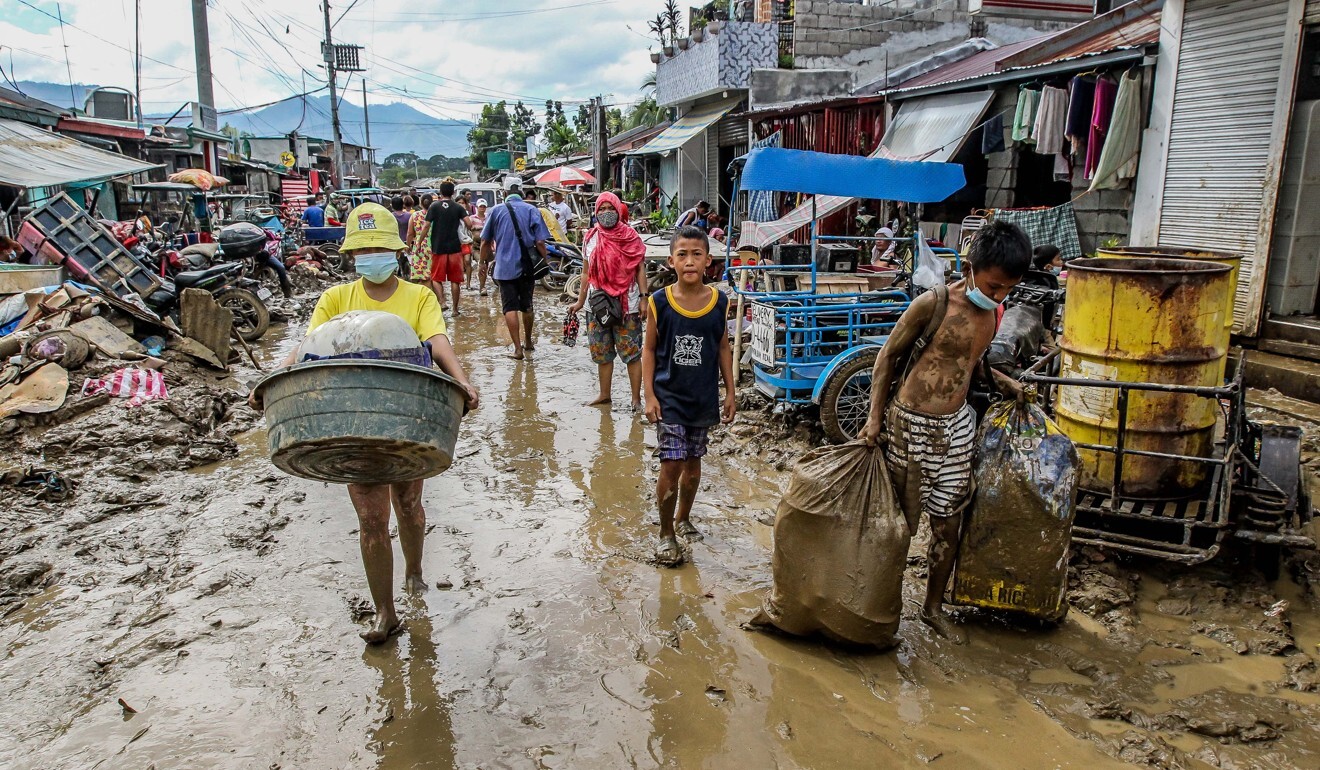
[880,91,994,161]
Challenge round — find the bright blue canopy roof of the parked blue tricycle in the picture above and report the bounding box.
[739,147,968,203]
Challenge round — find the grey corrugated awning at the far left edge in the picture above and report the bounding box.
[0,120,158,188]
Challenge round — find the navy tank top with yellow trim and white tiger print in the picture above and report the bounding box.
[651,287,729,428]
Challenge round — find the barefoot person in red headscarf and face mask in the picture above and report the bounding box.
[569,193,647,412]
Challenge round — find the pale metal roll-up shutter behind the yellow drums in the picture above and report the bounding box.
[1159,0,1288,330]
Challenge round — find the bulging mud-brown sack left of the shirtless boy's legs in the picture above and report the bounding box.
[752,441,912,647]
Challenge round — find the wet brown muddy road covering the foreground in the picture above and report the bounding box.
[0,289,1320,770]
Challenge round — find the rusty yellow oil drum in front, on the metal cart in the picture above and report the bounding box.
[1056,258,1233,499]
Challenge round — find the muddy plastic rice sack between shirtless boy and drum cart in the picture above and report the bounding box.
[952,403,1077,621]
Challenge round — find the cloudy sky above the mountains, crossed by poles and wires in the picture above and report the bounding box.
[0,0,660,119]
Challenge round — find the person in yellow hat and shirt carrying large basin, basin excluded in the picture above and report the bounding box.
[248,203,479,645]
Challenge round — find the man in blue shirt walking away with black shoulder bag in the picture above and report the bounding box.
[482,186,550,361]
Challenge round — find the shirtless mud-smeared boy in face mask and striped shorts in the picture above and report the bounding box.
[862,222,1031,645]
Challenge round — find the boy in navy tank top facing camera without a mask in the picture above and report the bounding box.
[642,227,737,567]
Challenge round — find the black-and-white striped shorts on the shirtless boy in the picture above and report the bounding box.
[884,402,977,516]
